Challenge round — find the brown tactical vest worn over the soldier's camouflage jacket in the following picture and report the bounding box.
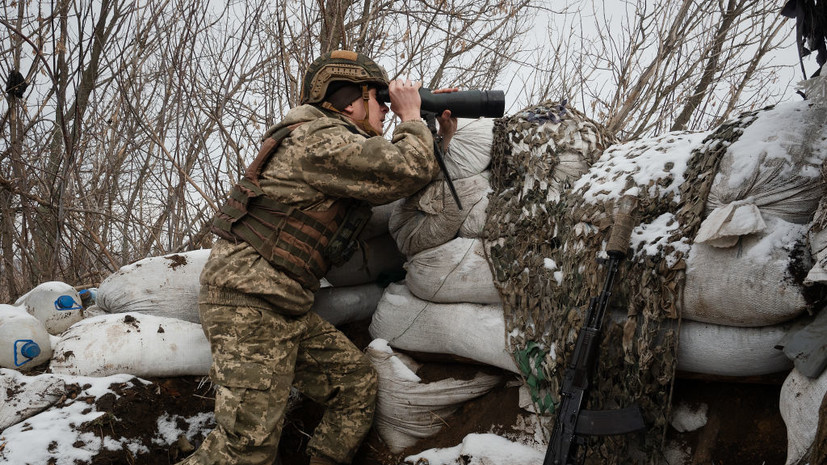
[212,123,371,291]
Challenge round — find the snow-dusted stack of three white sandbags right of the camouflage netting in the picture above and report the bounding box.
[679,102,827,376]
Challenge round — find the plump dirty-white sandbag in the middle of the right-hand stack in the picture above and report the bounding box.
[682,215,807,327]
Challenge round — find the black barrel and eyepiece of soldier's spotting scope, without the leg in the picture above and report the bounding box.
[376,87,505,118]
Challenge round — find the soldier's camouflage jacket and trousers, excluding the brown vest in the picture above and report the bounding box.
[181,105,438,465]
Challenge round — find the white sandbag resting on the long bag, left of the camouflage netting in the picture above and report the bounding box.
[405,237,502,304]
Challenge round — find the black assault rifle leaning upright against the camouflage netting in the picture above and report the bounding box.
[543,197,646,465]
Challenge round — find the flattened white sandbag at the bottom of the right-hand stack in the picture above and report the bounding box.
[677,320,793,377]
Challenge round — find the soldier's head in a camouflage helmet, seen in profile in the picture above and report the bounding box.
[299,50,389,135]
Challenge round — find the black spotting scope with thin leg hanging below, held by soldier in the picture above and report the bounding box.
[376,87,505,210]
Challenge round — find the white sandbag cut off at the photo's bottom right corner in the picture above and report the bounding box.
[778,369,827,465]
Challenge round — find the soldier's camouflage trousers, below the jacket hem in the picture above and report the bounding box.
[180,282,377,465]
